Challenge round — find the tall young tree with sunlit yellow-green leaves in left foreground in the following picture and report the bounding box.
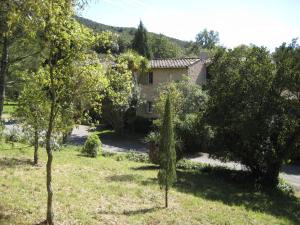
[28,0,107,225]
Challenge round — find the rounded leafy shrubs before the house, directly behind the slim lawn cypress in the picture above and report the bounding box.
[155,79,211,154]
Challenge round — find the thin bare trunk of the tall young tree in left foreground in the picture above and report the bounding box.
[46,101,55,225]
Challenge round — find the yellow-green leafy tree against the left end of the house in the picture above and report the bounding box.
[102,51,148,133]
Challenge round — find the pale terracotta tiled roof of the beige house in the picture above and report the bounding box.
[150,58,201,68]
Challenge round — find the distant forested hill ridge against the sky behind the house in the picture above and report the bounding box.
[76,16,189,49]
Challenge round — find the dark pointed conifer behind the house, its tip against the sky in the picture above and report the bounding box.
[132,21,151,59]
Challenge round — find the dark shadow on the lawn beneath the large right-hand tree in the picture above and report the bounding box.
[175,168,300,224]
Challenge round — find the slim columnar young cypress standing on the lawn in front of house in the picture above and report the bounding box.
[158,96,176,208]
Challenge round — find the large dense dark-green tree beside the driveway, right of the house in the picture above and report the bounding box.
[207,46,300,187]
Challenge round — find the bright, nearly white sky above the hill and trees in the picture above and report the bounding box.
[80,0,300,51]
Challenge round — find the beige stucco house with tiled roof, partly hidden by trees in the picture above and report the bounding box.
[136,57,206,118]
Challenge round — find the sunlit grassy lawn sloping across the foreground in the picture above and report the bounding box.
[0,143,300,225]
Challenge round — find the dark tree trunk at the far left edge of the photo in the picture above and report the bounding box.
[0,35,9,120]
